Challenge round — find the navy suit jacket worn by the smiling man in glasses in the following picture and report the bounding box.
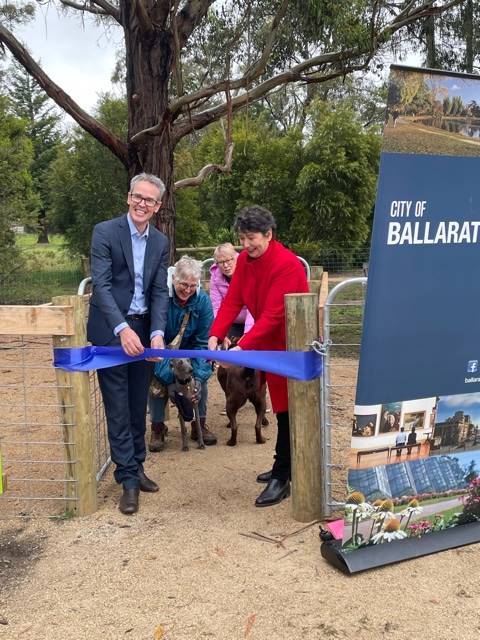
[87,215,169,345]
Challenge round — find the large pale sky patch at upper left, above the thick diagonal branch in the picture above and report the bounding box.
[15,4,122,113]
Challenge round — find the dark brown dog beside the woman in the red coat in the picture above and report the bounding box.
[217,365,268,447]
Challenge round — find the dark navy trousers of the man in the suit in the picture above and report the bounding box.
[97,317,153,489]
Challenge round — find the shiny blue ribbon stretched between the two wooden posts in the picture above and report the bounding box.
[53,347,322,380]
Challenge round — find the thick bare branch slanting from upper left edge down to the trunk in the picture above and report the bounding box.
[0,25,128,168]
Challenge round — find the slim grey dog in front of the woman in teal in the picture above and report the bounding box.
[168,358,205,451]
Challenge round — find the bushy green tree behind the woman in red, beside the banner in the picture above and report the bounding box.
[290,102,380,252]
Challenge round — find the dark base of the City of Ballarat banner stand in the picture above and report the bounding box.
[320,522,480,575]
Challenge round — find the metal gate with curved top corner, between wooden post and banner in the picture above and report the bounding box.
[320,278,367,515]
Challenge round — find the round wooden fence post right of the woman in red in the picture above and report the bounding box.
[285,293,325,522]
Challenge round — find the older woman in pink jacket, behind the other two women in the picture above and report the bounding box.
[210,242,254,338]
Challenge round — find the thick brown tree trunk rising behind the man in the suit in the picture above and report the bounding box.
[120,0,175,262]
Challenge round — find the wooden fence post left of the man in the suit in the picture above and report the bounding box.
[52,296,97,516]
